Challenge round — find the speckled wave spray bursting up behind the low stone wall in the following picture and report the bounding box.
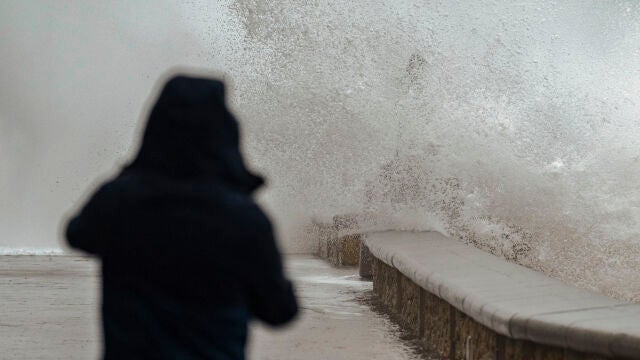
[232,0,640,301]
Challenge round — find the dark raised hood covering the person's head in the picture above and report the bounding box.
[127,76,263,192]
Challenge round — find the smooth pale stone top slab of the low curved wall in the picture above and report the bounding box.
[364,231,640,358]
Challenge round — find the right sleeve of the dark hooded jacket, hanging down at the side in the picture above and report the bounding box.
[248,208,298,326]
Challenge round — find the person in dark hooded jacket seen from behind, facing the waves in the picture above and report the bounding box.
[66,76,297,360]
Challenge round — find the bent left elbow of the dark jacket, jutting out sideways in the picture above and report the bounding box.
[65,188,107,256]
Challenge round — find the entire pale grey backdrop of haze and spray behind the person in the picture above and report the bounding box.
[0,0,640,301]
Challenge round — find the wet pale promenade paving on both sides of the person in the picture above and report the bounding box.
[0,256,430,360]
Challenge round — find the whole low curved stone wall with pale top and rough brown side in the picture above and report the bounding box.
[363,232,640,360]
